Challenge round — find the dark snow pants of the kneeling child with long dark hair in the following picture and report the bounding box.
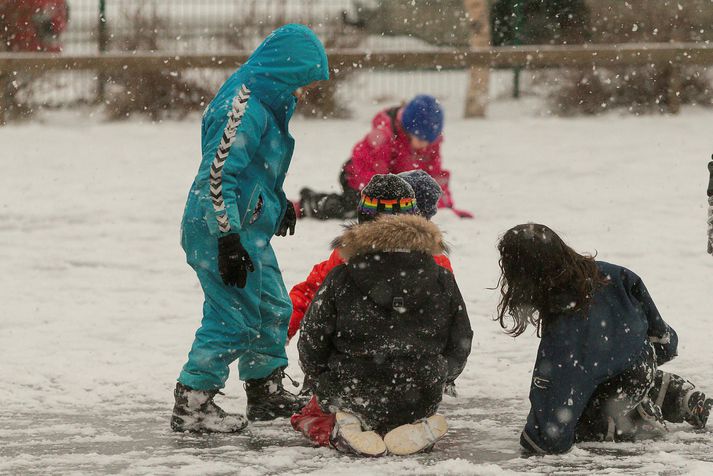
[576,349,695,441]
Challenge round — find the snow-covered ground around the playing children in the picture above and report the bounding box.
[0,99,713,475]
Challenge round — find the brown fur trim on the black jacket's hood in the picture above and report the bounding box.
[332,215,448,261]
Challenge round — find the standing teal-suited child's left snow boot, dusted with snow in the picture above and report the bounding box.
[171,383,248,433]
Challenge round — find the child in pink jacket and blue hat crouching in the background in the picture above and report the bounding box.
[295,95,473,220]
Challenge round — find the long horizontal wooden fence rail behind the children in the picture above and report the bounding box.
[0,43,713,73]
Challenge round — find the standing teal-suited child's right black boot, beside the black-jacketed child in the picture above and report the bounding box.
[245,367,304,421]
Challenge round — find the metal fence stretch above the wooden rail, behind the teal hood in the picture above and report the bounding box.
[63,0,394,53]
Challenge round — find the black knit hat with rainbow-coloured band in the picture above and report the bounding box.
[357,174,416,223]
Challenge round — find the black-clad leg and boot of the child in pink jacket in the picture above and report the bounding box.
[300,162,359,220]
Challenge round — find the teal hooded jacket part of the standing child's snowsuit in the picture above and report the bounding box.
[195,25,329,244]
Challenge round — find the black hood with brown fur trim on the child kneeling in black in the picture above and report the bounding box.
[333,215,448,313]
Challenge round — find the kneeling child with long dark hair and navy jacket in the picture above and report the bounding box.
[497,223,713,453]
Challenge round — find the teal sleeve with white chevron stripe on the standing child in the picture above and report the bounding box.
[201,99,267,236]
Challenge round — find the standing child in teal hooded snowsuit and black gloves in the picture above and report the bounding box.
[171,25,329,432]
